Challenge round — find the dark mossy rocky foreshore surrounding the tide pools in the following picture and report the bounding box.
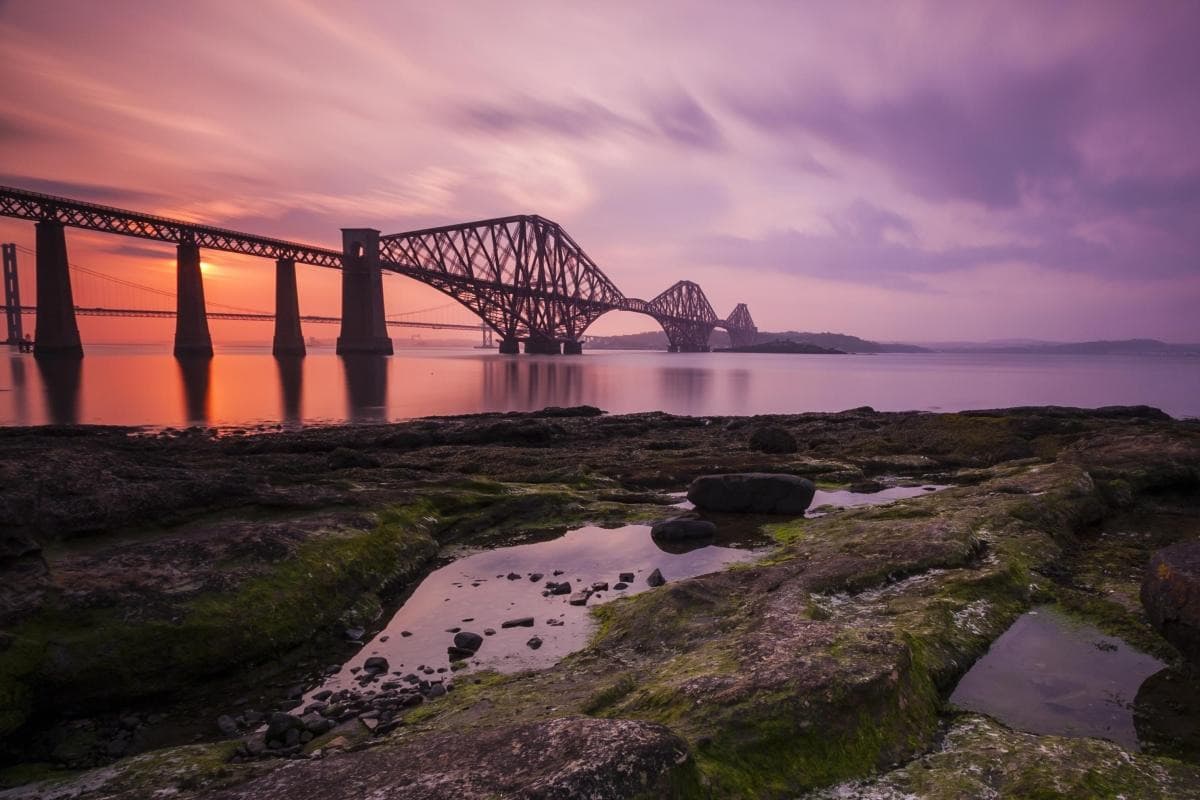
[0,408,1200,799]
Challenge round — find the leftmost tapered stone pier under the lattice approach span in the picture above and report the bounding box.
[34,222,83,359]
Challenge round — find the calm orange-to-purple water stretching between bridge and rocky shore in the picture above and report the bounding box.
[0,345,1200,427]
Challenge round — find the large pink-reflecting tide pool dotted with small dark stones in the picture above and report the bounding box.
[313,525,768,691]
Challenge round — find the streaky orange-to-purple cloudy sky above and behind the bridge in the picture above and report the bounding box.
[0,0,1200,341]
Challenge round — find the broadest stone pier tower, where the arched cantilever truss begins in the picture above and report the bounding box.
[337,228,392,355]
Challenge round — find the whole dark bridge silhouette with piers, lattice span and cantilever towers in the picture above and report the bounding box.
[0,186,757,356]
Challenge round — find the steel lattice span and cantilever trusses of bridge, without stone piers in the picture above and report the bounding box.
[0,187,756,351]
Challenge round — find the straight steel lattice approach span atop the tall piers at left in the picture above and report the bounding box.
[0,186,342,269]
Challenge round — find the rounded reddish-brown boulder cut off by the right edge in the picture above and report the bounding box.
[1141,542,1200,666]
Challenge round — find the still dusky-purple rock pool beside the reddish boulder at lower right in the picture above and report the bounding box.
[950,606,1164,750]
